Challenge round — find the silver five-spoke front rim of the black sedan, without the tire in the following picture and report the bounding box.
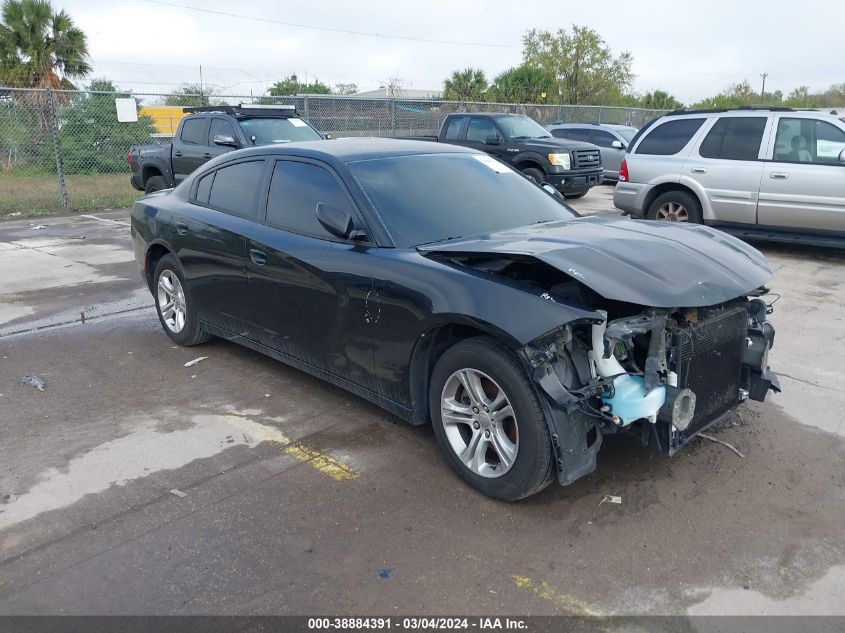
[440,368,519,478]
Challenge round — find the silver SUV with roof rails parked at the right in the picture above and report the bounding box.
[613,108,845,241]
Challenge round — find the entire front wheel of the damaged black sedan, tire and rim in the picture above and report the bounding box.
[429,337,555,501]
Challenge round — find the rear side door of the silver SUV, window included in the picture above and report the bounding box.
[681,115,771,224]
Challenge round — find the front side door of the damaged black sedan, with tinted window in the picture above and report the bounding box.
[247,158,375,390]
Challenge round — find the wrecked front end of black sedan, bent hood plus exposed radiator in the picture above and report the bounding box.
[418,218,780,485]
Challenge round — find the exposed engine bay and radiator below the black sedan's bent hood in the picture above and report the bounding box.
[432,248,780,484]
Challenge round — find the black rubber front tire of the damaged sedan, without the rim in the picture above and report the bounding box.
[429,336,556,501]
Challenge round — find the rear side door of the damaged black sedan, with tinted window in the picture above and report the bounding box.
[173,159,267,338]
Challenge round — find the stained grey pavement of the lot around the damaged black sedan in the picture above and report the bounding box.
[0,187,845,615]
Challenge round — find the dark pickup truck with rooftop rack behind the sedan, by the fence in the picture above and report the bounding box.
[128,105,327,193]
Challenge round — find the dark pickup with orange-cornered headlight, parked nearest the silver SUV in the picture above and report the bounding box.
[410,112,604,198]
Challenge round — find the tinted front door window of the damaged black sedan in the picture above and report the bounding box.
[267,160,354,240]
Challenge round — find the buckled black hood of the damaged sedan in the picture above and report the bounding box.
[418,216,772,308]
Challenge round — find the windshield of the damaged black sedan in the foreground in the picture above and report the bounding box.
[348,154,575,248]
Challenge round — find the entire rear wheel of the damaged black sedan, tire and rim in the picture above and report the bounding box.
[153,255,211,346]
